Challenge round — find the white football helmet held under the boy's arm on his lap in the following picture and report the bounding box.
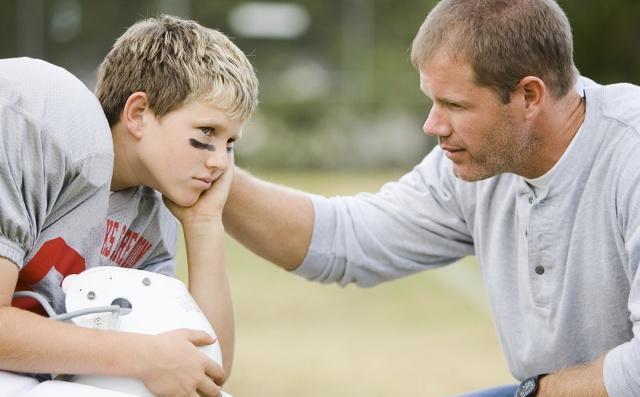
[62,266,228,397]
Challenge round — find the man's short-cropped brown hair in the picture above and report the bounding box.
[411,0,578,103]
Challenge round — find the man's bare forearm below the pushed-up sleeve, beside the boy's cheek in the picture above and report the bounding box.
[223,168,314,270]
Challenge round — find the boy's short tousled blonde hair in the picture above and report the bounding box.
[96,15,258,126]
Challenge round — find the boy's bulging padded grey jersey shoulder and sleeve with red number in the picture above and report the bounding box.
[0,58,113,311]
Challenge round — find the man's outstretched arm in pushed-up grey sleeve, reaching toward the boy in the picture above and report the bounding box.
[223,151,474,287]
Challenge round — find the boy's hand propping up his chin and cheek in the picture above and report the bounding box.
[163,154,234,227]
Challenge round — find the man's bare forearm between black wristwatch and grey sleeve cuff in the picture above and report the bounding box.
[536,354,609,397]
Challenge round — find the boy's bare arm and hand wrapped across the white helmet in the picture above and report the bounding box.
[0,257,221,396]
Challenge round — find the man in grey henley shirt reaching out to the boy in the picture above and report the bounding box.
[225,0,640,397]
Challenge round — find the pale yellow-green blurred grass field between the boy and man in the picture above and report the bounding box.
[176,172,514,397]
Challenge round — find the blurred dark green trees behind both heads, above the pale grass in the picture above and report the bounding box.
[0,0,640,170]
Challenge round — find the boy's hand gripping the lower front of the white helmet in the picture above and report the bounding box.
[140,329,225,397]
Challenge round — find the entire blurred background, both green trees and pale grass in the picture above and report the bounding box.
[0,0,640,397]
